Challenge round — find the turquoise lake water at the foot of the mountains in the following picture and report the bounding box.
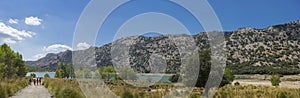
[26,72,170,82]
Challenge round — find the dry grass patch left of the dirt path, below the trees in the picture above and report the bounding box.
[0,78,29,98]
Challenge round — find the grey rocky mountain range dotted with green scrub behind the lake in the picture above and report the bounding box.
[26,21,300,73]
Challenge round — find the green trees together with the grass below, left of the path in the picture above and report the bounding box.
[0,44,29,98]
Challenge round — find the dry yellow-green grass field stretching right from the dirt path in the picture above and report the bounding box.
[44,79,300,98]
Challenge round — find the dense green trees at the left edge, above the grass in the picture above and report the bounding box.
[0,44,27,78]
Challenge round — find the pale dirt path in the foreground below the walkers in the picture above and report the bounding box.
[11,85,52,98]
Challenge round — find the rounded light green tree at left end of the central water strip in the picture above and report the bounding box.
[118,66,137,80]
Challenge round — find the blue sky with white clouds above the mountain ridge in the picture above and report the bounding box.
[0,0,300,60]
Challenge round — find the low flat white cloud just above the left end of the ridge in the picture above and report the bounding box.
[43,44,72,53]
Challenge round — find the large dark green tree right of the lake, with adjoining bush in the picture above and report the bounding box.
[183,49,234,87]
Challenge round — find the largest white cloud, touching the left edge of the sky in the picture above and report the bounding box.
[0,22,36,43]
